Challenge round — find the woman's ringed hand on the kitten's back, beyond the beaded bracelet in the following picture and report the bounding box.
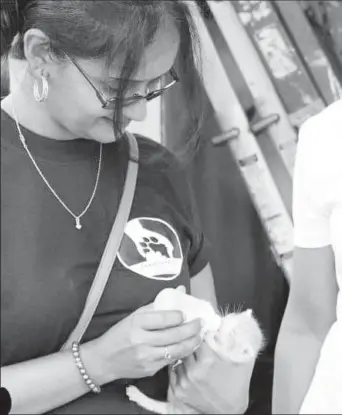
[87,304,202,383]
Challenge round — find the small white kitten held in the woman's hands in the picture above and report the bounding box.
[126,286,264,414]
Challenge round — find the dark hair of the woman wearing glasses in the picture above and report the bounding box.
[1,0,203,157]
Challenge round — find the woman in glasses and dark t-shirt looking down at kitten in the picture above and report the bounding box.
[1,0,248,413]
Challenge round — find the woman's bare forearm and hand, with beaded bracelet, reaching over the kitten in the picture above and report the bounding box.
[1,303,201,414]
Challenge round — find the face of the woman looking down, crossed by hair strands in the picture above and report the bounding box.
[39,17,180,143]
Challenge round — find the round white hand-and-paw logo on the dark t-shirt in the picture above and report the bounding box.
[118,218,183,279]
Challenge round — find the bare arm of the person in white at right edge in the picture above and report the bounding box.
[272,246,338,414]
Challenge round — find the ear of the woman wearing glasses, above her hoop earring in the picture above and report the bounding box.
[24,29,52,78]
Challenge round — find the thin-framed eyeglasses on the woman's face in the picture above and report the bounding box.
[66,54,180,109]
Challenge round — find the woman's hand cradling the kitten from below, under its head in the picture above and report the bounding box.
[170,342,255,414]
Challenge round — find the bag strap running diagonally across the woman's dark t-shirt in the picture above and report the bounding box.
[62,132,139,350]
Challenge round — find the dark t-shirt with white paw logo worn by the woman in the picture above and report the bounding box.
[1,111,208,413]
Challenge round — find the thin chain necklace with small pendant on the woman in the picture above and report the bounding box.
[12,101,102,230]
